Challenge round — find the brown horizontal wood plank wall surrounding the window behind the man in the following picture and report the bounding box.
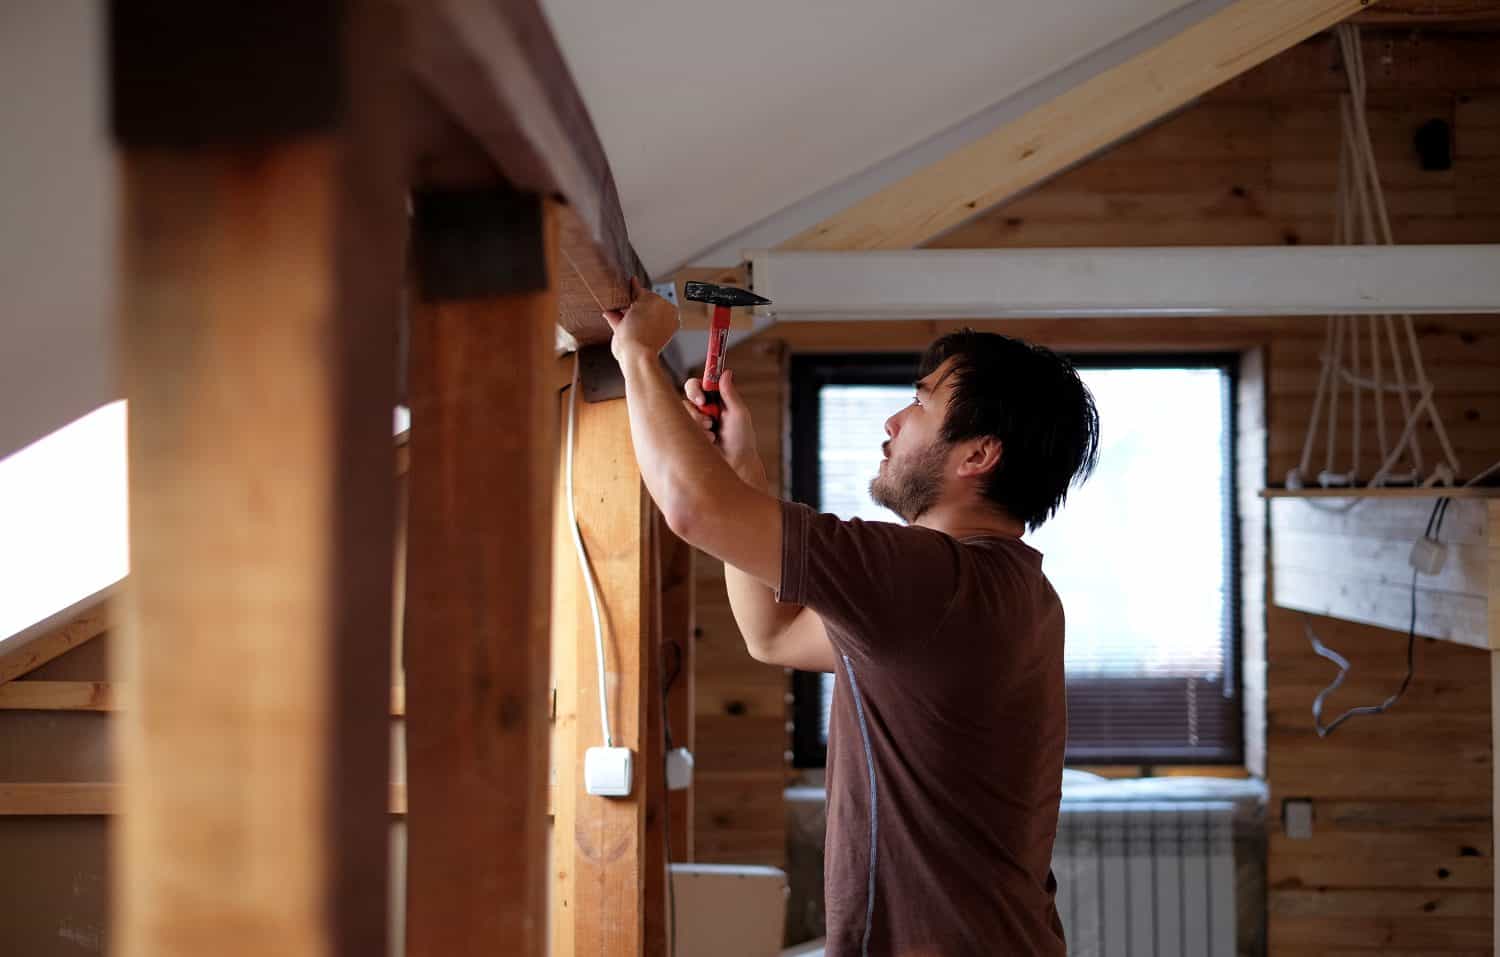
[698,32,1500,956]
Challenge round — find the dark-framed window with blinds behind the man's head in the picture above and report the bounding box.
[792,356,1244,767]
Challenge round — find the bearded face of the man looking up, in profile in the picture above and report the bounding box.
[870,359,956,522]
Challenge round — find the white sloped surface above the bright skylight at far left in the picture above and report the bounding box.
[0,0,117,458]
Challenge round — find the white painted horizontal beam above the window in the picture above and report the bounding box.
[749,245,1500,321]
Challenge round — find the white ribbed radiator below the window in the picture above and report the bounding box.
[1052,801,1235,957]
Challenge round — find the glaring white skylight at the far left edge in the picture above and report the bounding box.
[0,401,131,641]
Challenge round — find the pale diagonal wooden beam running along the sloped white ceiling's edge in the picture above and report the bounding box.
[783,0,1368,249]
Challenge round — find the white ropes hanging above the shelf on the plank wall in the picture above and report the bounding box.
[1287,24,1464,488]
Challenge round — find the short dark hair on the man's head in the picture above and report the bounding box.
[918,329,1100,531]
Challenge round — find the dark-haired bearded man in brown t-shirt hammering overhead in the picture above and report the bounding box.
[605,282,1098,957]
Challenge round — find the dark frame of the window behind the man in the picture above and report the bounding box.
[789,351,1247,770]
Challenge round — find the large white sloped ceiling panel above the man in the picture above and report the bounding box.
[543,0,1206,276]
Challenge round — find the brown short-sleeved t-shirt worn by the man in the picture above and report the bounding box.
[777,503,1068,957]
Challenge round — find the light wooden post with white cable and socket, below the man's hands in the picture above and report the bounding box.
[552,396,660,957]
